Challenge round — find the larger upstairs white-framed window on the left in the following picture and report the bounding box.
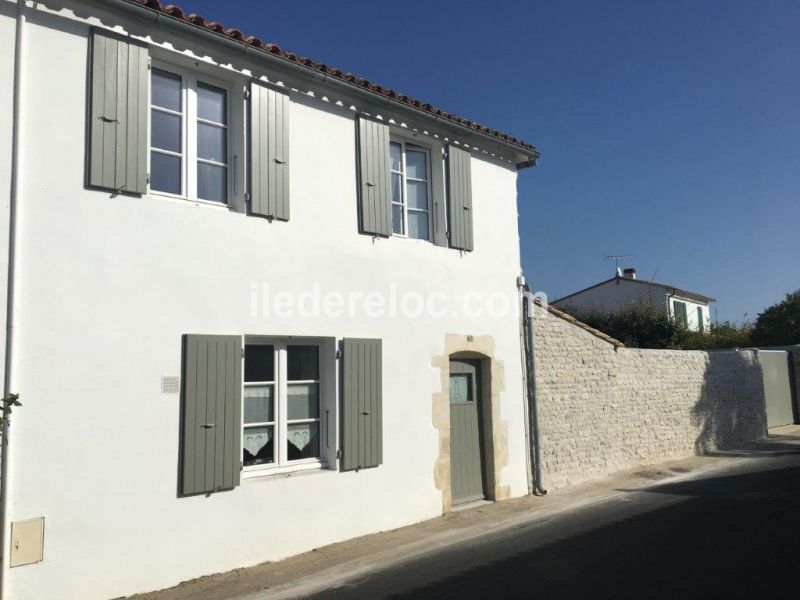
[150,67,230,204]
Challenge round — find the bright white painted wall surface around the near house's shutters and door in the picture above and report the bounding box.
[0,2,527,600]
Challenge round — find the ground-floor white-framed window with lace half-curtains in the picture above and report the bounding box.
[242,341,321,468]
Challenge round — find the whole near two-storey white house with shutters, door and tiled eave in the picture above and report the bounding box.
[0,0,538,600]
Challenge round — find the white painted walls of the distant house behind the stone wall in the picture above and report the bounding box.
[553,277,711,331]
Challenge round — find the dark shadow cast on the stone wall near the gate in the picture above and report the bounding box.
[692,350,775,455]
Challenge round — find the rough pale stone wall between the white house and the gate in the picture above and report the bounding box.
[534,307,766,488]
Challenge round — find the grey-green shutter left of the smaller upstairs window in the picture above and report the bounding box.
[356,116,392,237]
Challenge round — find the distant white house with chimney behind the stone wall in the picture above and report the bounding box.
[552,268,715,331]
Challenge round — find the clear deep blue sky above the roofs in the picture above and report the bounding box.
[172,0,800,321]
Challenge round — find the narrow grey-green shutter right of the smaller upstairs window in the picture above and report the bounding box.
[447,145,473,250]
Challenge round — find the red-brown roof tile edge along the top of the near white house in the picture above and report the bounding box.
[119,0,539,166]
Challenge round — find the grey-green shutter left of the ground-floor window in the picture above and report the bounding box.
[181,335,242,495]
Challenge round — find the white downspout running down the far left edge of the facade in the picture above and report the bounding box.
[0,0,26,600]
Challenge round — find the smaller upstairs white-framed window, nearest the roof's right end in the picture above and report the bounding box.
[389,139,431,240]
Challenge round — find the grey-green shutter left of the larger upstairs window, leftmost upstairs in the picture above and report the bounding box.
[87,29,150,194]
